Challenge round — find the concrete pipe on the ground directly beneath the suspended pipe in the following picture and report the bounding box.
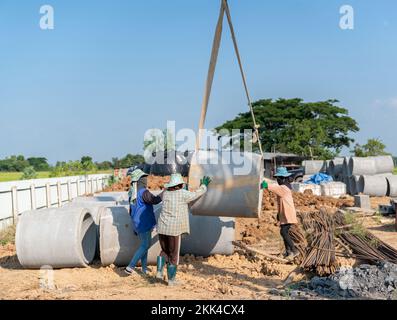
[181,215,235,257]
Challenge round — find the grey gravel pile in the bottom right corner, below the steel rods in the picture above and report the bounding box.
[309,263,397,300]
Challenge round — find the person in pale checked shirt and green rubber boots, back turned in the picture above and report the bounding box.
[156,174,211,286]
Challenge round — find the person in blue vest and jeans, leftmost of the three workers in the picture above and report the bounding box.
[125,169,162,275]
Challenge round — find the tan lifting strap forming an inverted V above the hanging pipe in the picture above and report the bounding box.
[196,0,263,156]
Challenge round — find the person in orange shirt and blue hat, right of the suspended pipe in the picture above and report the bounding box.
[262,167,299,261]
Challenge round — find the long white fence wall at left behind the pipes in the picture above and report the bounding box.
[0,174,110,230]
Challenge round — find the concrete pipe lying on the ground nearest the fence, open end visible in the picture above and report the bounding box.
[16,208,97,269]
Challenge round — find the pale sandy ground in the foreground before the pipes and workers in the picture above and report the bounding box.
[0,245,294,300]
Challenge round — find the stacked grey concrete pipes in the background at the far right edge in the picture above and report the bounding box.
[327,156,397,197]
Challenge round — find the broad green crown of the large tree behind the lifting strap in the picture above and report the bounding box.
[216,98,359,159]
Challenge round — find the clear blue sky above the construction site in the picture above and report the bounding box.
[0,0,397,162]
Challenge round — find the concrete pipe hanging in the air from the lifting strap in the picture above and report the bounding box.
[189,151,264,218]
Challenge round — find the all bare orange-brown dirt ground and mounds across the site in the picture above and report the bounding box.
[0,178,397,300]
